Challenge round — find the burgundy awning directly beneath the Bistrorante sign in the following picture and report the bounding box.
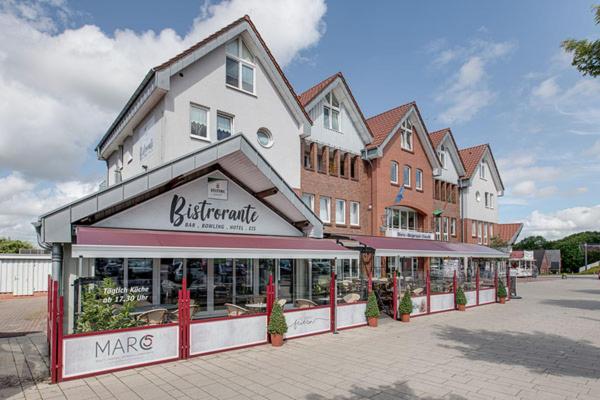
[72,226,359,258]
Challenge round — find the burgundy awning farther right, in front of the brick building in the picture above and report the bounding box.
[352,236,508,258]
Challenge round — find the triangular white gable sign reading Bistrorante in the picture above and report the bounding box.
[94,171,302,236]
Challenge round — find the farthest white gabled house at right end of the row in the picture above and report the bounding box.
[460,144,504,245]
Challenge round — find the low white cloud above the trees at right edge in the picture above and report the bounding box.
[521,205,600,239]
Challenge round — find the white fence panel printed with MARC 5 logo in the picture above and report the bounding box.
[63,326,179,378]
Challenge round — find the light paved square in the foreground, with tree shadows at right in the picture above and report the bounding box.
[0,279,600,400]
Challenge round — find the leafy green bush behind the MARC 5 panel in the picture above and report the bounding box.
[76,278,140,332]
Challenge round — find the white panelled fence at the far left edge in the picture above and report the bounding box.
[0,254,52,296]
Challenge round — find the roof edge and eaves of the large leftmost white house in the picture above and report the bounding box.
[96,15,312,154]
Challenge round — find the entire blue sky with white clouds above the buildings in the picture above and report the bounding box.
[0,0,600,241]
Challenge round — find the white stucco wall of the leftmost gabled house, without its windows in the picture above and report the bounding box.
[107,34,308,188]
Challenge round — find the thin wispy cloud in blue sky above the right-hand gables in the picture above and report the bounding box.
[433,40,516,124]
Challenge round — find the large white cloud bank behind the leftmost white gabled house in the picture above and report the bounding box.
[0,0,327,242]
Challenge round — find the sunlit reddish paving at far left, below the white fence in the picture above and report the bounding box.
[0,296,48,338]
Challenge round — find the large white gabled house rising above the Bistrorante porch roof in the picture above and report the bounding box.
[96,16,312,188]
